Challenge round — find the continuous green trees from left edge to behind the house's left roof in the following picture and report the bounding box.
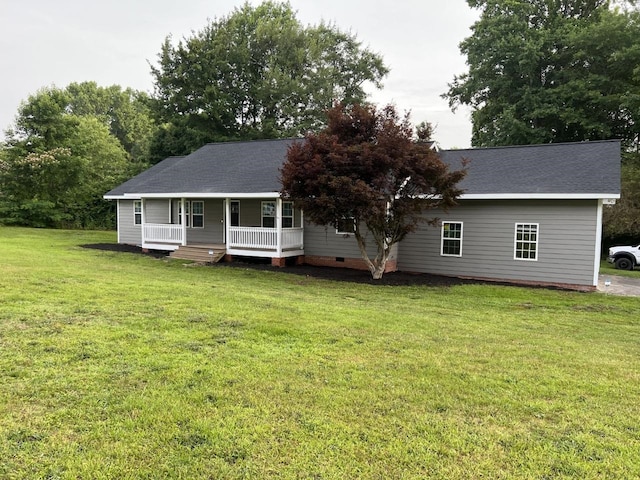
[0,1,388,228]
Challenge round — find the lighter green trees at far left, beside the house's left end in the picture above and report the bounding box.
[0,82,153,227]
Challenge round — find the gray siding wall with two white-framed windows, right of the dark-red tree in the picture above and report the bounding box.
[398,200,598,285]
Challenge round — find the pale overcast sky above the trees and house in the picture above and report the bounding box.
[0,0,478,148]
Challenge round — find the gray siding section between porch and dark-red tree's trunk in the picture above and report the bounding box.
[304,222,397,260]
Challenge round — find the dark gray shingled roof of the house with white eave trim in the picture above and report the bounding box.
[105,139,620,199]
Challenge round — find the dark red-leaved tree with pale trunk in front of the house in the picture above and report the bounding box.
[281,105,465,279]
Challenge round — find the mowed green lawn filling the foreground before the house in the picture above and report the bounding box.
[0,228,640,479]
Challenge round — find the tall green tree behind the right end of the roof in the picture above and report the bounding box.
[444,0,640,148]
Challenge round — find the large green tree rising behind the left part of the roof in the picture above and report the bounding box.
[152,1,387,160]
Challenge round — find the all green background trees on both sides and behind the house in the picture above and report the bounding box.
[0,0,640,237]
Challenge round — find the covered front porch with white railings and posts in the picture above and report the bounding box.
[139,197,304,258]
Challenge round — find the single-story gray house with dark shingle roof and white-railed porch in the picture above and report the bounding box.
[104,139,620,290]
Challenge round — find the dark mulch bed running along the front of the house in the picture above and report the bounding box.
[81,243,484,287]
